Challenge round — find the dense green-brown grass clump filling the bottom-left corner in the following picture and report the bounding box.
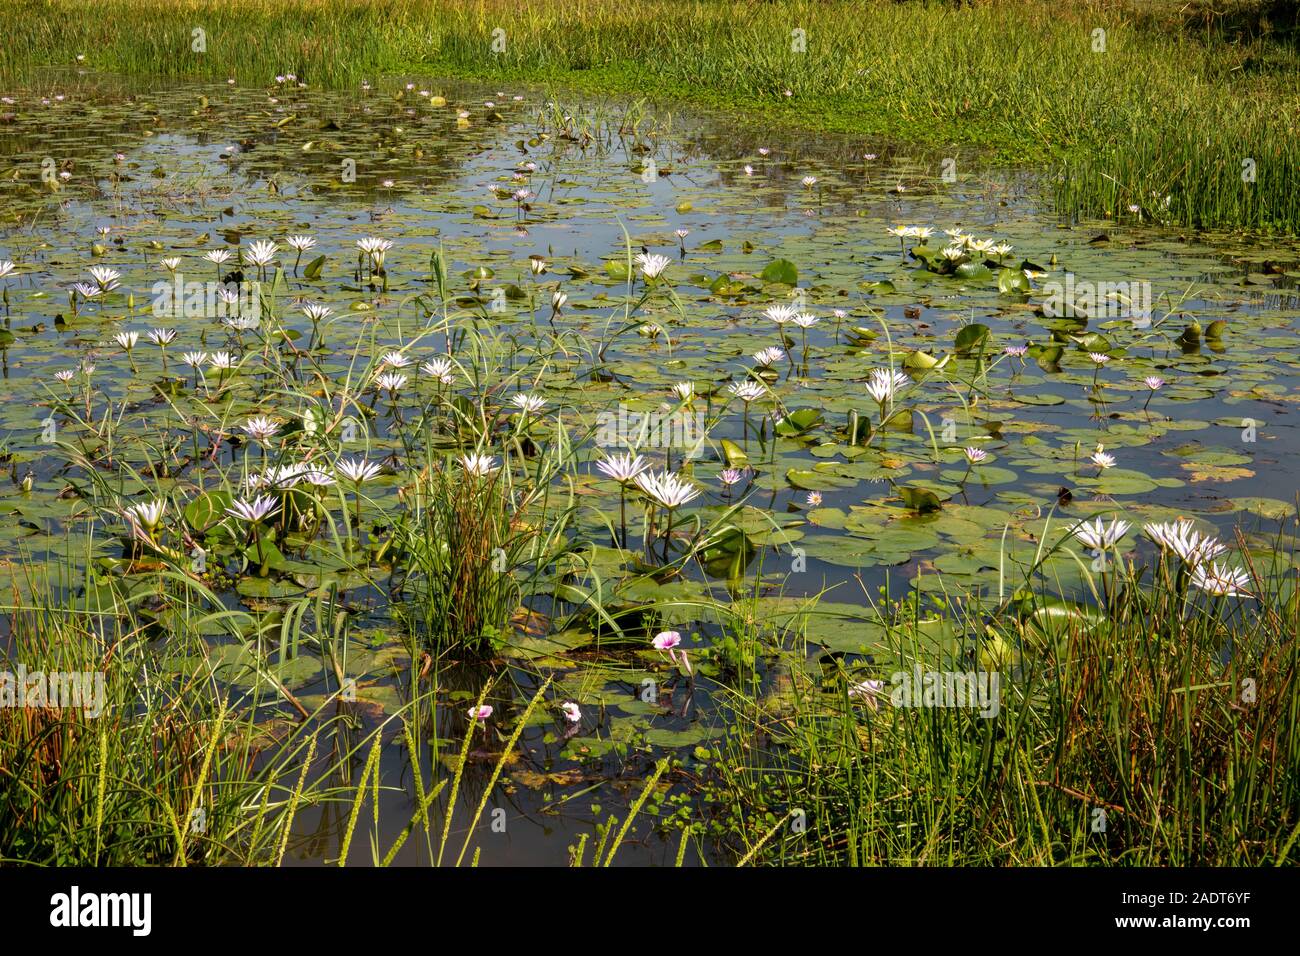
[0,546,329,866]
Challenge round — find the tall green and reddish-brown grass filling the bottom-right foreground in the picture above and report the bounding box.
[706,530,1300,866]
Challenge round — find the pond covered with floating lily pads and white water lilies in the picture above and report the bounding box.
[0,75,1300,865]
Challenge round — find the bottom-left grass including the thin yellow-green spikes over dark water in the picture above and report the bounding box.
[0,546,579,866]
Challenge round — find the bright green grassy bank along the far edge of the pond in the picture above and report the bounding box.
[0,0,1300,232]
